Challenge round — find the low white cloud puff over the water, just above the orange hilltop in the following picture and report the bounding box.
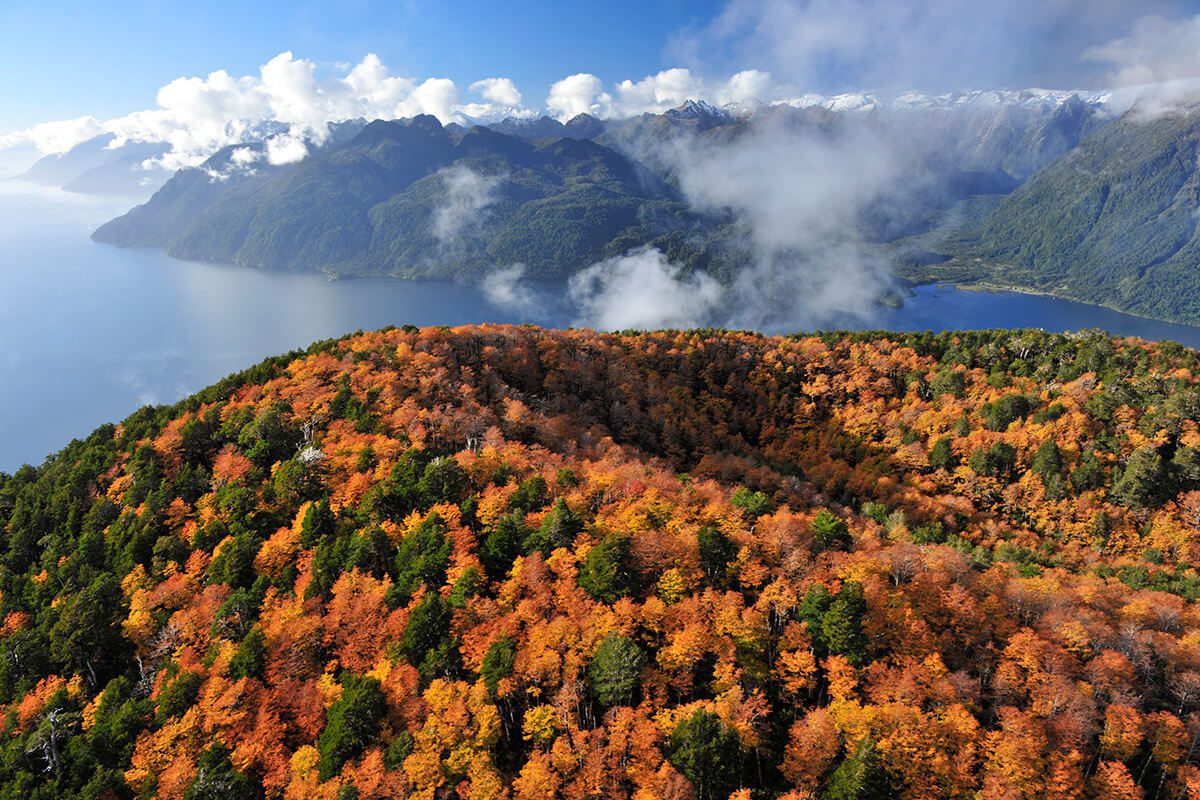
[568,247,725,331]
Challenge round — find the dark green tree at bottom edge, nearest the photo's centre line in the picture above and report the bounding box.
[667,711,743,800]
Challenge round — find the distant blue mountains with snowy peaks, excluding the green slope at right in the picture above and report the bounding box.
[88,95,1103,286]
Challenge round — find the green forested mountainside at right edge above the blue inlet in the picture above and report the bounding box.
[947,108,1200,323]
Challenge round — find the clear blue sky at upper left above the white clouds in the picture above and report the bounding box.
[0,0,721,131]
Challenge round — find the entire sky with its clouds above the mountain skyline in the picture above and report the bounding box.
[0,0,1200,168]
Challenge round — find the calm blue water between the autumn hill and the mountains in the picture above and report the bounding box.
[7,181,1200,471]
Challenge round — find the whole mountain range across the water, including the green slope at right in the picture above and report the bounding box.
[77,91,1200,321]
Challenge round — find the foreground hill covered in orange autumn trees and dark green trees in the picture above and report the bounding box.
[7,326,1200,800]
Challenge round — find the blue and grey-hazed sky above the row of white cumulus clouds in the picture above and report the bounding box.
[0,0,1200,137]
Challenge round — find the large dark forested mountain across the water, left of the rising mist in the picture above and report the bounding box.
[94,116,716,277]
